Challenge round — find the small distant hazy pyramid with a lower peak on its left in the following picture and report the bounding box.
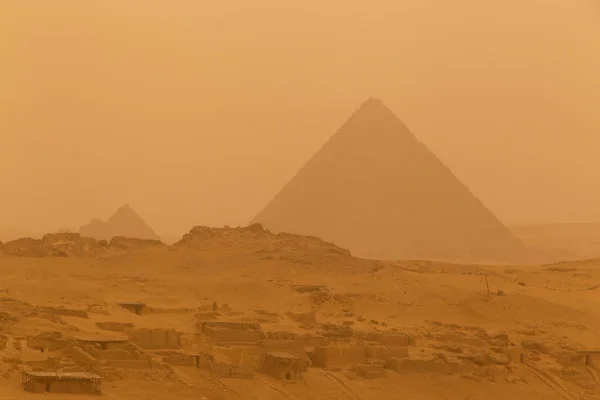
[79,204,160,240]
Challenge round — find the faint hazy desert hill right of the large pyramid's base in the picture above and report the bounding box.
[510,223,600,262]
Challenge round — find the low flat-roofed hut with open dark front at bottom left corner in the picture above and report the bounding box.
[22,372,102,395]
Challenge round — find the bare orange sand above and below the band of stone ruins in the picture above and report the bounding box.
[0,236,600,400]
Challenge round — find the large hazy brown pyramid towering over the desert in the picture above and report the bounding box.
[253,99,527,263]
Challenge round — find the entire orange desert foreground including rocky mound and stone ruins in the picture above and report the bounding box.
[0,225,600,400]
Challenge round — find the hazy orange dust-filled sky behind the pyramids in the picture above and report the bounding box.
[0,0,600,234]
